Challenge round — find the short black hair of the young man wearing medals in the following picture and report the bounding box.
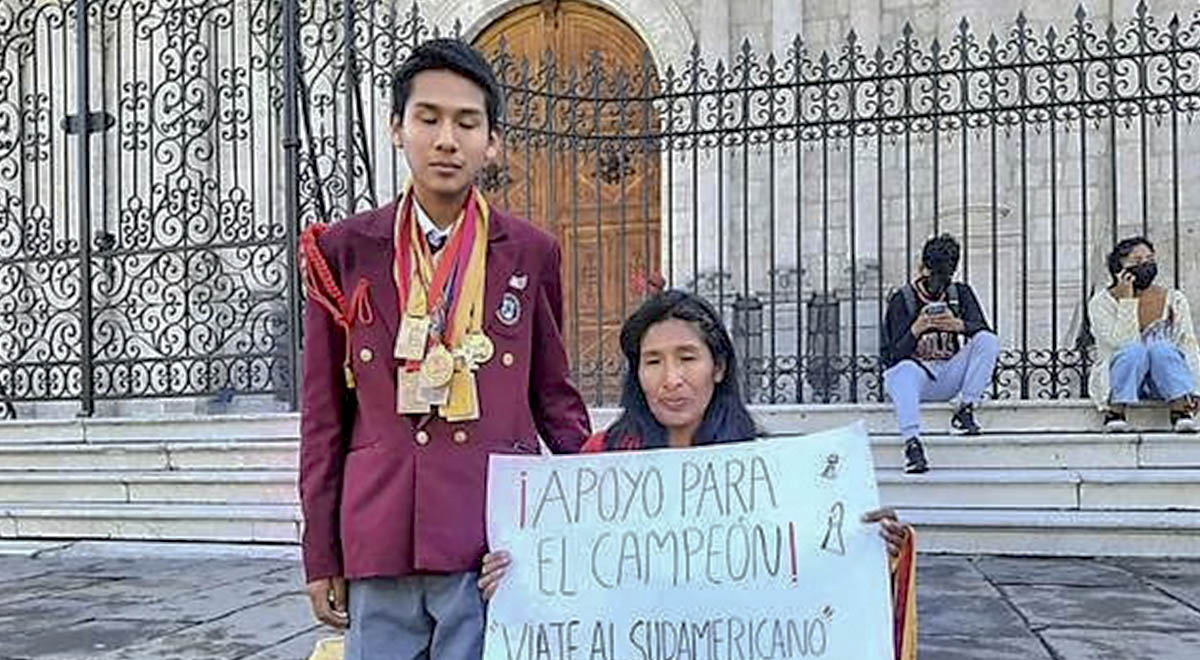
[391,38,504,131]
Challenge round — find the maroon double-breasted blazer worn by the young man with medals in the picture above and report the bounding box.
[300,203,589,581]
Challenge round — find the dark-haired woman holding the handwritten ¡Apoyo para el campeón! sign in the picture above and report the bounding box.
[479,290,917,659]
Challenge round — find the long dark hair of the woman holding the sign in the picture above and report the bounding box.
[607,290,758,449]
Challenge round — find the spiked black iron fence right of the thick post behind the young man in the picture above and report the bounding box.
[306,2,1200,404]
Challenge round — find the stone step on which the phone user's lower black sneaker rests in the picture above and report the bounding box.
[876,469,1200,511]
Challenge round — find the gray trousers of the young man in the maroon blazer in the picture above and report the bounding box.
[346,572,484,660]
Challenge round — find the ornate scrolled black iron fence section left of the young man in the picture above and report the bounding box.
[0,0,295,414]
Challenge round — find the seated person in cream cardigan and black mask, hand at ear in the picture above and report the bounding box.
[1087,236,1200,433]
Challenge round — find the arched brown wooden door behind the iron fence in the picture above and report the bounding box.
[475,1,661,404]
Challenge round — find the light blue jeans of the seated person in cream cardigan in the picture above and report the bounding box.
[1109,341,1195,403]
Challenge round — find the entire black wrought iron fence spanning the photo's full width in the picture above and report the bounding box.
[0,0,1200,414]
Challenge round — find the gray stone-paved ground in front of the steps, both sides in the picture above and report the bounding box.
[0,556,1200,660]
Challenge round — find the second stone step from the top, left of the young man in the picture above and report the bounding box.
[0,439,299,473]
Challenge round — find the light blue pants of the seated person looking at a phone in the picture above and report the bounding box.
[883,332,1000,438]
